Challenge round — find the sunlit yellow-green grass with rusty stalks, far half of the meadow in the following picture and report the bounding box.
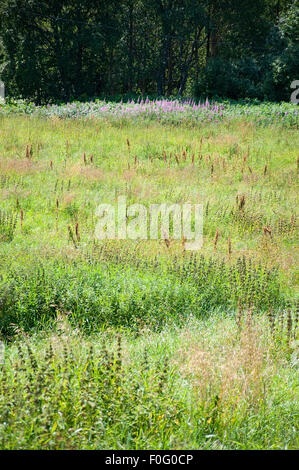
[0,117,299,289]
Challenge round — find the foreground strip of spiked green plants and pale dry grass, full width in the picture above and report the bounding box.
[0,317,298,450]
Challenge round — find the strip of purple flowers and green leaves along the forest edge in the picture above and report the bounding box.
[0,98,299,128]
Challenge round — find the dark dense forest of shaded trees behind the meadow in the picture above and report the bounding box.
[0,0,299,103]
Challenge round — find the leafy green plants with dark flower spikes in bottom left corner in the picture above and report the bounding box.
[0,340,182,449]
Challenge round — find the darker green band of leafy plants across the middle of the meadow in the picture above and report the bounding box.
[0,256,284,335]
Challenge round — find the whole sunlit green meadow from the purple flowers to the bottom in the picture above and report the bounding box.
[0,105,299,449]
